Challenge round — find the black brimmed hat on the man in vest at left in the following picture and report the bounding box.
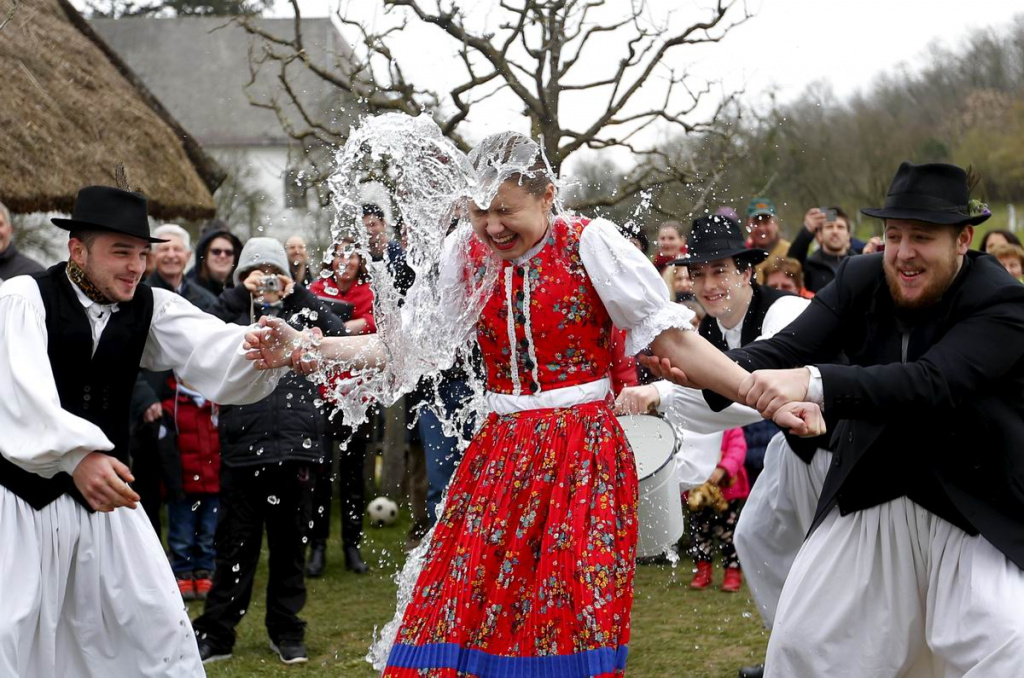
[50,186,167,243]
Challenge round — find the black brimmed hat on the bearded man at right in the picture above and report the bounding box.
[860,162,991,225]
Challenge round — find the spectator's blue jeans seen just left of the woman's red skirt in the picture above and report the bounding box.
[419,381,473,525]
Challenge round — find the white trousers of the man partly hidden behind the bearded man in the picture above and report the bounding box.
[733,433,833,629]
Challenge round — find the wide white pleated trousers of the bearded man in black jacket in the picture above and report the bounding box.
[765,498,1024,678]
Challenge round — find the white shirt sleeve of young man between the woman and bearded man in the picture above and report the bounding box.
[654,296,820,433]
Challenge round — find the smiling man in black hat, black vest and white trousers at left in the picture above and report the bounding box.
[0,186,284,678]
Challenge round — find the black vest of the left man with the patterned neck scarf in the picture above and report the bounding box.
[0,262,153,510]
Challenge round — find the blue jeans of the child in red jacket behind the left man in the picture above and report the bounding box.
[167,495,220,578]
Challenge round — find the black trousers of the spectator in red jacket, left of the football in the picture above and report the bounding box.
[309,418,373,546]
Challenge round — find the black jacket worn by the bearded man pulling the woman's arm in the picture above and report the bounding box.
[708,252,1024,567]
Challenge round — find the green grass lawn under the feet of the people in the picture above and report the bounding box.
[189,510,768,678]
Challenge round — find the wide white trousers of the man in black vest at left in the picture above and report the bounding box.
[0,486,206,678]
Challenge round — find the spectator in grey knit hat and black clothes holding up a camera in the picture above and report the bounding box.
[194,238,346,664]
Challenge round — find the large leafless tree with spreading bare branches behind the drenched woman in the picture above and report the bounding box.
[239,0,751,203]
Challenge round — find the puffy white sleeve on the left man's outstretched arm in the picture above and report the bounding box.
[142,289,288,405]
